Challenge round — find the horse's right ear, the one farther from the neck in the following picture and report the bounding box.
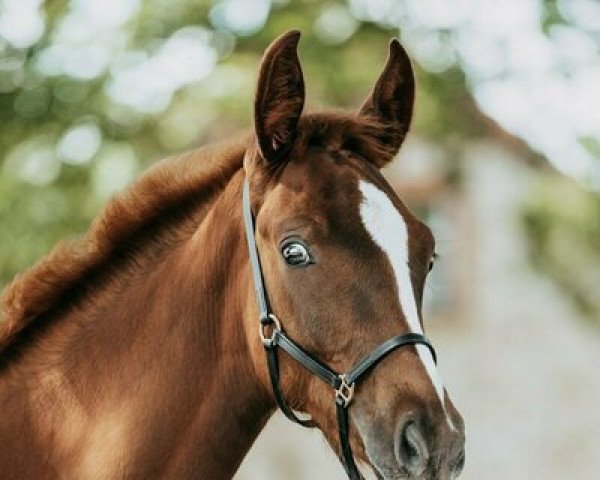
[359,39,415,165]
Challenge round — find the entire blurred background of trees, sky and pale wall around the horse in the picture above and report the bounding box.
[0,0,600,480]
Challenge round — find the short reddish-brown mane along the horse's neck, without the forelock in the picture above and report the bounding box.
[0,134,251,352]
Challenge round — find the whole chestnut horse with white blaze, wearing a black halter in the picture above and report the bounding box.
[0,31,465,480]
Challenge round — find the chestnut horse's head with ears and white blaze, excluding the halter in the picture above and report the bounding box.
[244,32,464,479]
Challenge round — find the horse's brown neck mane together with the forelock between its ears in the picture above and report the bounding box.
[0,112,400,353]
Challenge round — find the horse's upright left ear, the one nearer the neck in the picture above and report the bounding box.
[254,30,304,164]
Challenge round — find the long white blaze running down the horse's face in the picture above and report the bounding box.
[358,180,454,429]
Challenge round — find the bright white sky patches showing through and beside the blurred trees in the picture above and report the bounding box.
[0,0,600,190]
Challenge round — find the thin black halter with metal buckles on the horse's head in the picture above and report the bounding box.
[243,180,437,480]
